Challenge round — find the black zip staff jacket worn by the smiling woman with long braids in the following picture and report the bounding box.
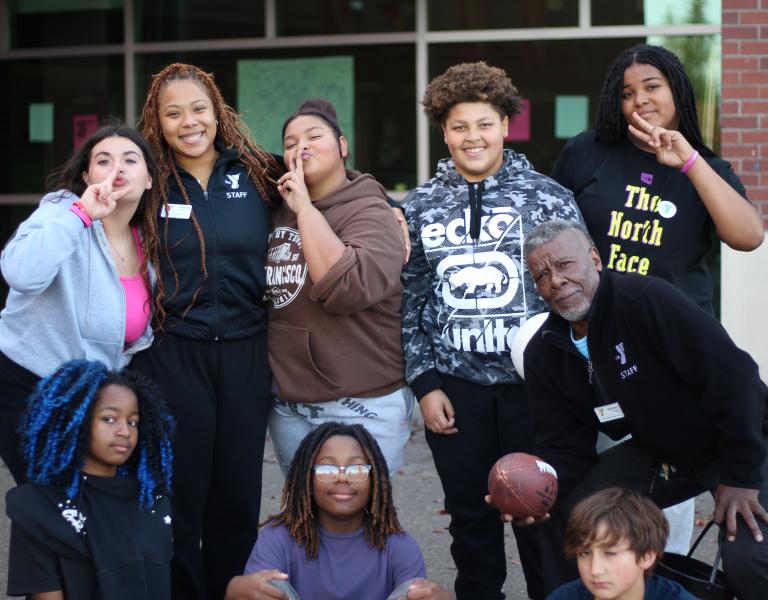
[158,144,280,340]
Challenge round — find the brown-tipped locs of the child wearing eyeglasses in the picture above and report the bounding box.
[262,421,403,560]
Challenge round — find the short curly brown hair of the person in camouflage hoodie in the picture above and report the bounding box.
[421,61,521,127]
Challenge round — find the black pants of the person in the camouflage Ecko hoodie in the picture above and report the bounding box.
[426,375,544,600]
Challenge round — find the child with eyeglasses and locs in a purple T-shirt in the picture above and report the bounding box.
[226,422,453,600]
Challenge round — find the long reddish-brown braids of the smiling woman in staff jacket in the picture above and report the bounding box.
[139,63,281,330]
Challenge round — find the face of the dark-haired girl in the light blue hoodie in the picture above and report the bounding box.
[83,135,152,204]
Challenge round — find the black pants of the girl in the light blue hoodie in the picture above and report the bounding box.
[0,352,40,483]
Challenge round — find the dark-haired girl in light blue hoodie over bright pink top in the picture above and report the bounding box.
[0,125,156,483]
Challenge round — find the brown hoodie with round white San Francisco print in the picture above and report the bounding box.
[266,170,405,403]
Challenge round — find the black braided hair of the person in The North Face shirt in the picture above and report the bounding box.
[594,44,715,156]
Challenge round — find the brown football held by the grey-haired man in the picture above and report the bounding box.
[488,452,557,519]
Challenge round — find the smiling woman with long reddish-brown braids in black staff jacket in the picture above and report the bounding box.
[134,64,280,600]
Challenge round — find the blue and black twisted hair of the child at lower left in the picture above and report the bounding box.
[19,360,174,508]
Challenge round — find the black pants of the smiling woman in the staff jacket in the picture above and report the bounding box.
[131,332,270,600]
